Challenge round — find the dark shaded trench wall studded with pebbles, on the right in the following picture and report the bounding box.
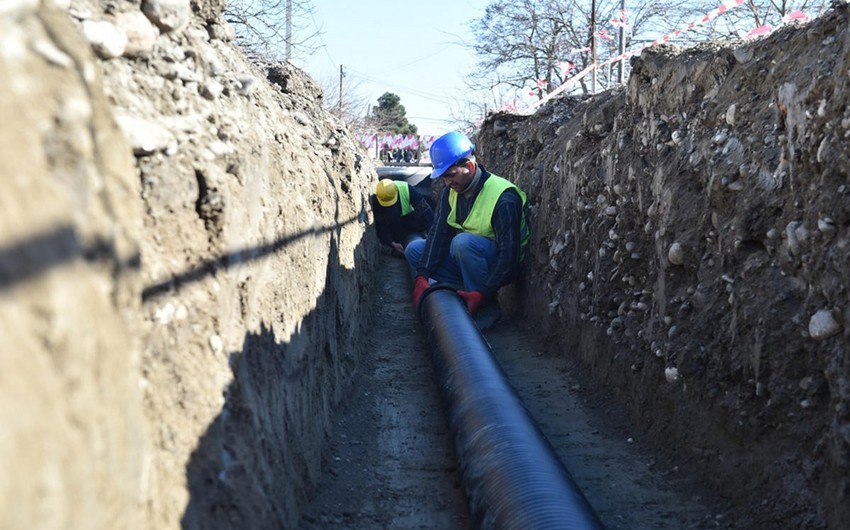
[477,6,850,528]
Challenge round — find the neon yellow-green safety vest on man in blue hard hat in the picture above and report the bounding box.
[446,173,531,250]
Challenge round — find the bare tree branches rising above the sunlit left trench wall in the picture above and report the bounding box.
[224,0,320,61]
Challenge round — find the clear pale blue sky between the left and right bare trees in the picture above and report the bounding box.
[293,0,490,136]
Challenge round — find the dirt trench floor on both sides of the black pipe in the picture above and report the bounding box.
[302,255,752,530]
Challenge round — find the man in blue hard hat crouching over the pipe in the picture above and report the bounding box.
[404,131,530,329]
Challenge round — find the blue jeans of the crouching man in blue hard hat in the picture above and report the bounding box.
[404,232,496,291]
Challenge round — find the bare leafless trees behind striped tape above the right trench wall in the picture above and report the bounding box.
[472,0,829,108]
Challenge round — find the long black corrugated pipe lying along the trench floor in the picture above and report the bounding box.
[419,285,602,530]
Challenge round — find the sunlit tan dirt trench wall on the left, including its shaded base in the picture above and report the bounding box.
[0,0,377,529]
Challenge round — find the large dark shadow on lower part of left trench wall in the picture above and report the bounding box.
[181,234,376,529]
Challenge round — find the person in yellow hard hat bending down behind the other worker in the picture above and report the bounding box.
[369,179,434,257]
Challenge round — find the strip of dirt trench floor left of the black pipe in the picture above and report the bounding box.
[303,254,467,529]
